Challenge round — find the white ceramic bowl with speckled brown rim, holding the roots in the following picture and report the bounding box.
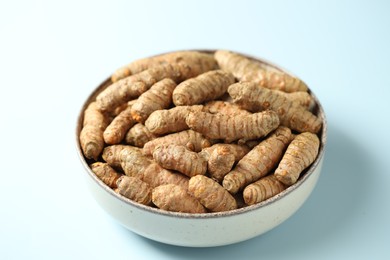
[76,50,327,247]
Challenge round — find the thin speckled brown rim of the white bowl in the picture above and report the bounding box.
[76,49,327,219]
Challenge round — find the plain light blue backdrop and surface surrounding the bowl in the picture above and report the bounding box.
[0,0,390,259]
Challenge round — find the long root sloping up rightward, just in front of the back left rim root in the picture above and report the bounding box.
[96,54,214,112]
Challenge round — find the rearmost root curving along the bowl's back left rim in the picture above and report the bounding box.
[111,51,217,82]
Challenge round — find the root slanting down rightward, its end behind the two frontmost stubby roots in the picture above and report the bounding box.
[120,150,188,189]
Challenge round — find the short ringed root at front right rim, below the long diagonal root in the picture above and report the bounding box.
[243,174,286,205]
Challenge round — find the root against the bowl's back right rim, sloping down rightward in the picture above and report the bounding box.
[214,50,308,92]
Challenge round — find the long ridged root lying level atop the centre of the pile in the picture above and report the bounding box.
[186,110,279,143]
